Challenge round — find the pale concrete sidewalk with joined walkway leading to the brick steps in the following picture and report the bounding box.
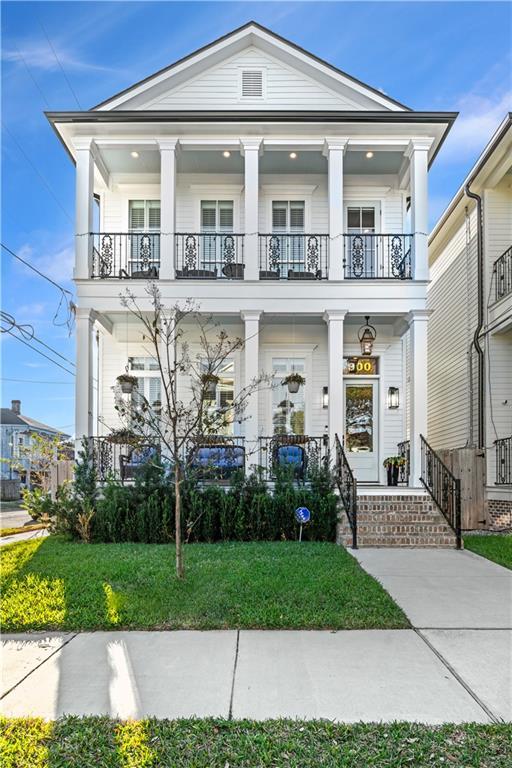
[1,550,512,724]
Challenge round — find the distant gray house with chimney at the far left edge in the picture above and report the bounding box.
[0,400,69,478]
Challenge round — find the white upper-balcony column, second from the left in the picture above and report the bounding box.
[158,139,178,280]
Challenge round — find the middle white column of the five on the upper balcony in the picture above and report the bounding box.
[240,138,262,280]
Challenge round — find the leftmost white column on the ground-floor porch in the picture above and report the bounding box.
[75,307,96,451]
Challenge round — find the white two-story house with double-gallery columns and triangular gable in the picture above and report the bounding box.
[48,23,456,500]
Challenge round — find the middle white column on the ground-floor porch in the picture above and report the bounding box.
[240,310,262,469]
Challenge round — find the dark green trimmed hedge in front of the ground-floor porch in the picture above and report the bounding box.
[77,466,338,544]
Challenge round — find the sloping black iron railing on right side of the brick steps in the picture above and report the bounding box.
[420,435,462,549]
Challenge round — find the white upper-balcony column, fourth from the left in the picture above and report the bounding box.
[324,138,347,280]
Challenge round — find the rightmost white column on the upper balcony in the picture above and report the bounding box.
[406,139,432,280]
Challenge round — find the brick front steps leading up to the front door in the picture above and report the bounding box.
[337,493,456,548]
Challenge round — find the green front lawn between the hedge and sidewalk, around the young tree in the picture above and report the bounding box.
[0,536,409,632]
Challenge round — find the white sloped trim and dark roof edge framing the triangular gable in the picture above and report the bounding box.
[93,21,409,111]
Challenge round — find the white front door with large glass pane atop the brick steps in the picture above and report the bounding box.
[344,379,379,483]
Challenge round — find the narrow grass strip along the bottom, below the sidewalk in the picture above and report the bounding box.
[0,717,512,768]
